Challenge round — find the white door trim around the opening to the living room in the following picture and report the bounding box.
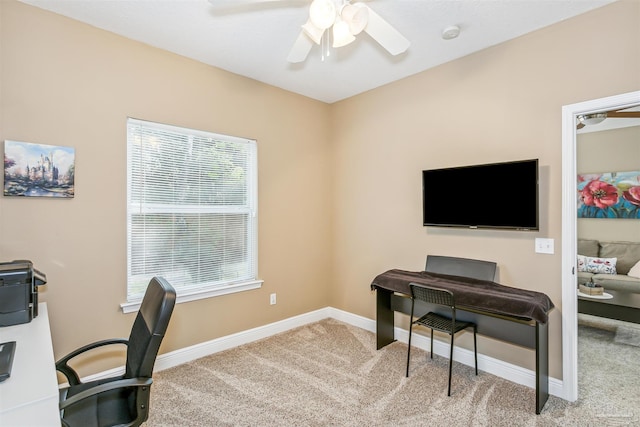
[561,91,640,402]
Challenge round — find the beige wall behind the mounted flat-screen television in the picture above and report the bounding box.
[331,1,640,378]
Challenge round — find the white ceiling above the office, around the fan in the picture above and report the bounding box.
[20,0,614,103]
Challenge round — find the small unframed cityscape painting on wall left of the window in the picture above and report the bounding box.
[4,141,75,198]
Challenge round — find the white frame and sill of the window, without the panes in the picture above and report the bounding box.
[120,118,262,313]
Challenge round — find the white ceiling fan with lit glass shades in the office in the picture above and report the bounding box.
[209,0,410,64]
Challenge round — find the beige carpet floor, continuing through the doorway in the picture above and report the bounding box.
[146,319,640,427]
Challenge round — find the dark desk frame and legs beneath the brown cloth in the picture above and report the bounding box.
[372,272,553,414]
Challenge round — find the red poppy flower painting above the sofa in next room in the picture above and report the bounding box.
[578,171,640,219]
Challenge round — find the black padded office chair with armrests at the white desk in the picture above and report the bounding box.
[56,277,176,427]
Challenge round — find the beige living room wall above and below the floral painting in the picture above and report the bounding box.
[576,125,640,242]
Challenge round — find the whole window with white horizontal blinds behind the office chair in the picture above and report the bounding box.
[123,119,260,312]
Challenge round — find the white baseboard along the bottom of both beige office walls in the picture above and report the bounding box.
[91,307,566,399]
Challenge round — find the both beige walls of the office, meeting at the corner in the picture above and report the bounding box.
[0,0,640,378]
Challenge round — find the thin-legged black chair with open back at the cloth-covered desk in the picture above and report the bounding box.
[406,283,478,396]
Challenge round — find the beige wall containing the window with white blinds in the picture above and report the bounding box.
[0,0,332,374]
